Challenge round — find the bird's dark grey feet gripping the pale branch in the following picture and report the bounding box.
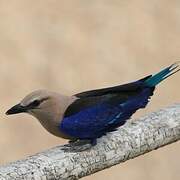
[63,140,96,152]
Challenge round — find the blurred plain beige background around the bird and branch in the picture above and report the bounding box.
[0,0,180,180]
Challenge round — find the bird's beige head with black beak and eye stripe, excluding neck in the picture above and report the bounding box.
[6,90,62,120]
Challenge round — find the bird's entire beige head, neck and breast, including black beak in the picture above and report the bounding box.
[6,90,76,138]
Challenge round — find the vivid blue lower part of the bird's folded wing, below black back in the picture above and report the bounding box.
[60,88,152,139]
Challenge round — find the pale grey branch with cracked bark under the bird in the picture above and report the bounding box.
[0,104,180,180]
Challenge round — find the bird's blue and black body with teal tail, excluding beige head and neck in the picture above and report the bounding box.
[59,63,180,139]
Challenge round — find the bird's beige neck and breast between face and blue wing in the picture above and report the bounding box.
[30,94,77,139]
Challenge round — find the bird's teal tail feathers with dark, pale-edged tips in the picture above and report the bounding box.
[144,61,180,87]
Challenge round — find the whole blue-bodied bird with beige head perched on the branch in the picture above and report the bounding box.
[6,62,180,146]
